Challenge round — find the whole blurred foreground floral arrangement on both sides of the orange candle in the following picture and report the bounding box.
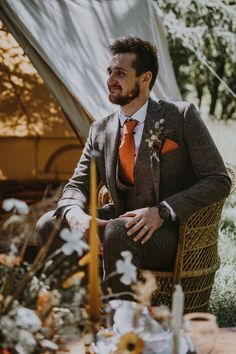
[0,199,166,354]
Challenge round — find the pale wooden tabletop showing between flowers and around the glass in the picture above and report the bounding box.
[58,328,236,354]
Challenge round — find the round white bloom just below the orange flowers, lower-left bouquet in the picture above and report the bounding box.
[16,307,42,332]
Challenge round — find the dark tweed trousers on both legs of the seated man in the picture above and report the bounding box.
[36,207,179,300]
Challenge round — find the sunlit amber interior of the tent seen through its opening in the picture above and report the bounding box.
[0,26,82,183]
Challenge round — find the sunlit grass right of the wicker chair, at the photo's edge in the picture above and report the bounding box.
[210,191,236,327]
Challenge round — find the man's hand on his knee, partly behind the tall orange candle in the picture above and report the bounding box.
[65,207,109,233]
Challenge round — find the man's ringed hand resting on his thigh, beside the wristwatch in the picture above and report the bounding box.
[120,207,164,244]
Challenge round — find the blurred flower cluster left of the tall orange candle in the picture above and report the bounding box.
[0,198,87,354]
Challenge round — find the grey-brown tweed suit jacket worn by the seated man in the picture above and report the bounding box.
[56,99,230,223]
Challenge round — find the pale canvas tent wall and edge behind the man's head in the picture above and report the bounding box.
[0,0,181,139]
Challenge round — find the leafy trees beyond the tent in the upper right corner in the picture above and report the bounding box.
[156,0,236,120]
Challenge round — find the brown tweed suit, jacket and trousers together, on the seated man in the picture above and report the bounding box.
[37,99,230,292]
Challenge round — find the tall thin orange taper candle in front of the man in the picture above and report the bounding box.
[89,157,99,321]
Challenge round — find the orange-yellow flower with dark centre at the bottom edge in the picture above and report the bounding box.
[117,332,144,354]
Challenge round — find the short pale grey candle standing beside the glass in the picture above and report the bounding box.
[171,285,184,354]
